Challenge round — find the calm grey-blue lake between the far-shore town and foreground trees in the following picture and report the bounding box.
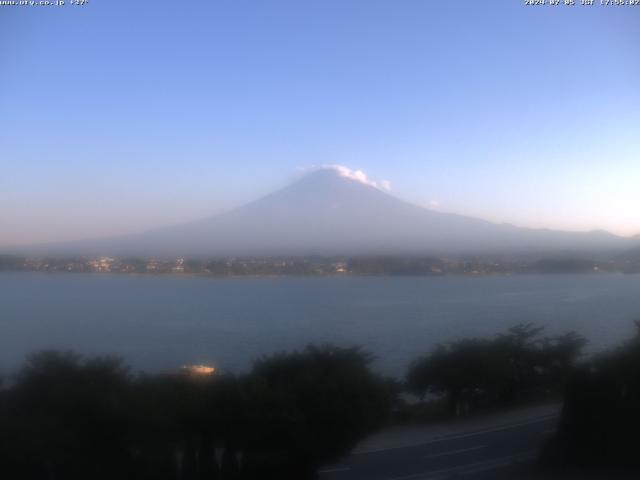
[0,273,640,375]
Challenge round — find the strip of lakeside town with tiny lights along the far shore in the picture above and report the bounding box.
[0,255,640,277]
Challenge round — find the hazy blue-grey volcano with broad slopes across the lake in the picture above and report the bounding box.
[7,169,640,257]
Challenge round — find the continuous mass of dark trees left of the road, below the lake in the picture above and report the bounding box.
[0,346,393,480]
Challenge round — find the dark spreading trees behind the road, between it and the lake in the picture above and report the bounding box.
[406,324,586,415]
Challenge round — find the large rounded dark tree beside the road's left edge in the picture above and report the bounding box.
[241,346,393,479]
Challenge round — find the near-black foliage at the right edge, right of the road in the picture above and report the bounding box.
[545,322,640,478]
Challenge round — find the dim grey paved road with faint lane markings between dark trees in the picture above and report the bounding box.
[319,406,558,480]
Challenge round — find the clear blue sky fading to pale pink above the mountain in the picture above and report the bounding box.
[0,0,640,245]
